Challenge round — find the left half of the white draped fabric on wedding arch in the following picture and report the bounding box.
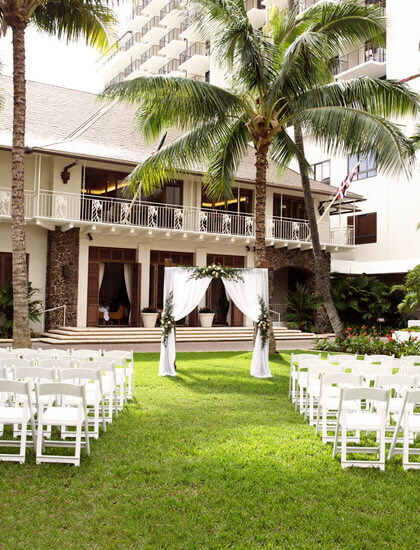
[159,267,211,376]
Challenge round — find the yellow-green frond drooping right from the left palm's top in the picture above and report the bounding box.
[31,0,117,51]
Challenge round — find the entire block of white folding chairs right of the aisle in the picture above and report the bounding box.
[289,354,420,470]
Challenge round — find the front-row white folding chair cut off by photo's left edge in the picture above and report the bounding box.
[0,379,36,464]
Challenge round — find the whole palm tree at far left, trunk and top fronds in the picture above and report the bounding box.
[0,0,115,347]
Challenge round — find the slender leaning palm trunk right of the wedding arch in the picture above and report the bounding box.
[294,124,344,338]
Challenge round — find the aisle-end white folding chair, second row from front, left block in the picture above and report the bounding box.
[58,368,106,439]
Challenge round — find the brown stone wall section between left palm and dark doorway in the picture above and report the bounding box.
[45,227,79,330]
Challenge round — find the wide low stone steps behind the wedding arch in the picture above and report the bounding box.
[39,327,315,345]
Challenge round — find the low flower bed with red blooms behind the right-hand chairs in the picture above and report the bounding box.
[315,325,420,357]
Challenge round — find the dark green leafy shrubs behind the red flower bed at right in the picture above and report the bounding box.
[331,273,404,327]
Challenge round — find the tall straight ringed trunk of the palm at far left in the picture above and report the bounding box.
[12,21,31,348]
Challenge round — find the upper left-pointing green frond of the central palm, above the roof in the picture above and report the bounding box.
[100,76,243,140]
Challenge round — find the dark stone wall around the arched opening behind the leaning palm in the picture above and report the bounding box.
[267,247,331,332]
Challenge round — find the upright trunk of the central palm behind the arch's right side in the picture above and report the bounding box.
[255,145,276,353]
